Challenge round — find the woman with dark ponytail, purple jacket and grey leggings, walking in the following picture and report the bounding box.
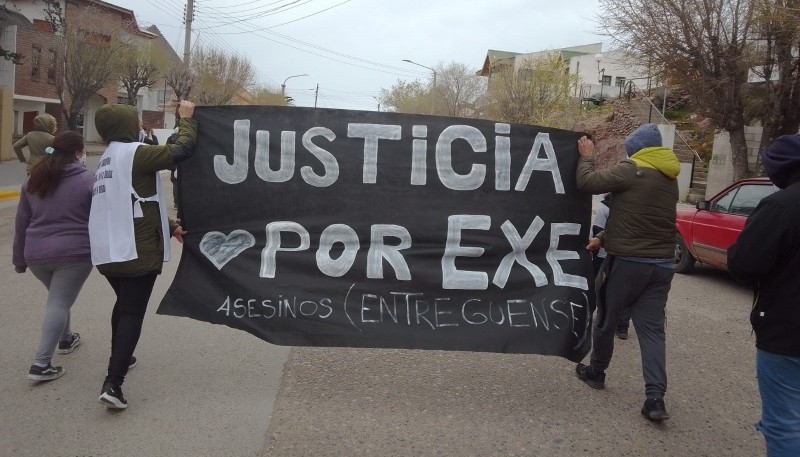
[13,131,94,381]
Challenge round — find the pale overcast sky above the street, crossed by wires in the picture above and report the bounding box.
[106,0,603,110]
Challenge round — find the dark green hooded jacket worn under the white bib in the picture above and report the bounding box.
[95,105,197,277]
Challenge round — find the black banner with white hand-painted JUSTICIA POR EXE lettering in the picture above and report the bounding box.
[158,106,594,361]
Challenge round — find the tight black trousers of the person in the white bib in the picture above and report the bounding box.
[106,273,158,386]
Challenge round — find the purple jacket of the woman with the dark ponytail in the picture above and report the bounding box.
[13,162,94,273]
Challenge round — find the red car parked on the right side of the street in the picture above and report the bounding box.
[675,178,778,273]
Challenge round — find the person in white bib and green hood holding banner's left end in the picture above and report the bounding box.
[89,101,197,409]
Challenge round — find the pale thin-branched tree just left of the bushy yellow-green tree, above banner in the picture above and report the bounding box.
[433,62,486,117]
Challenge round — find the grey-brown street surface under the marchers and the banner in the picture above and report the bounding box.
[0,157,764,457]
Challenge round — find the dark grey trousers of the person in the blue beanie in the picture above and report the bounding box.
[591,256,675,398]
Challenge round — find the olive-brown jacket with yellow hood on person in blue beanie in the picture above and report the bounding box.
[576,147,680,258]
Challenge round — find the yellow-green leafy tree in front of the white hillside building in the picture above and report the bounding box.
[488,52,578,128]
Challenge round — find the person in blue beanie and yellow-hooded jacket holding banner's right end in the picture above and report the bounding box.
[575,124,680,422]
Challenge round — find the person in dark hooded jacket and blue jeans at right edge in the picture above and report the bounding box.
[728,135,800,457]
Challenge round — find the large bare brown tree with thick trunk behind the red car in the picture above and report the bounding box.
[600,0,756,179]
